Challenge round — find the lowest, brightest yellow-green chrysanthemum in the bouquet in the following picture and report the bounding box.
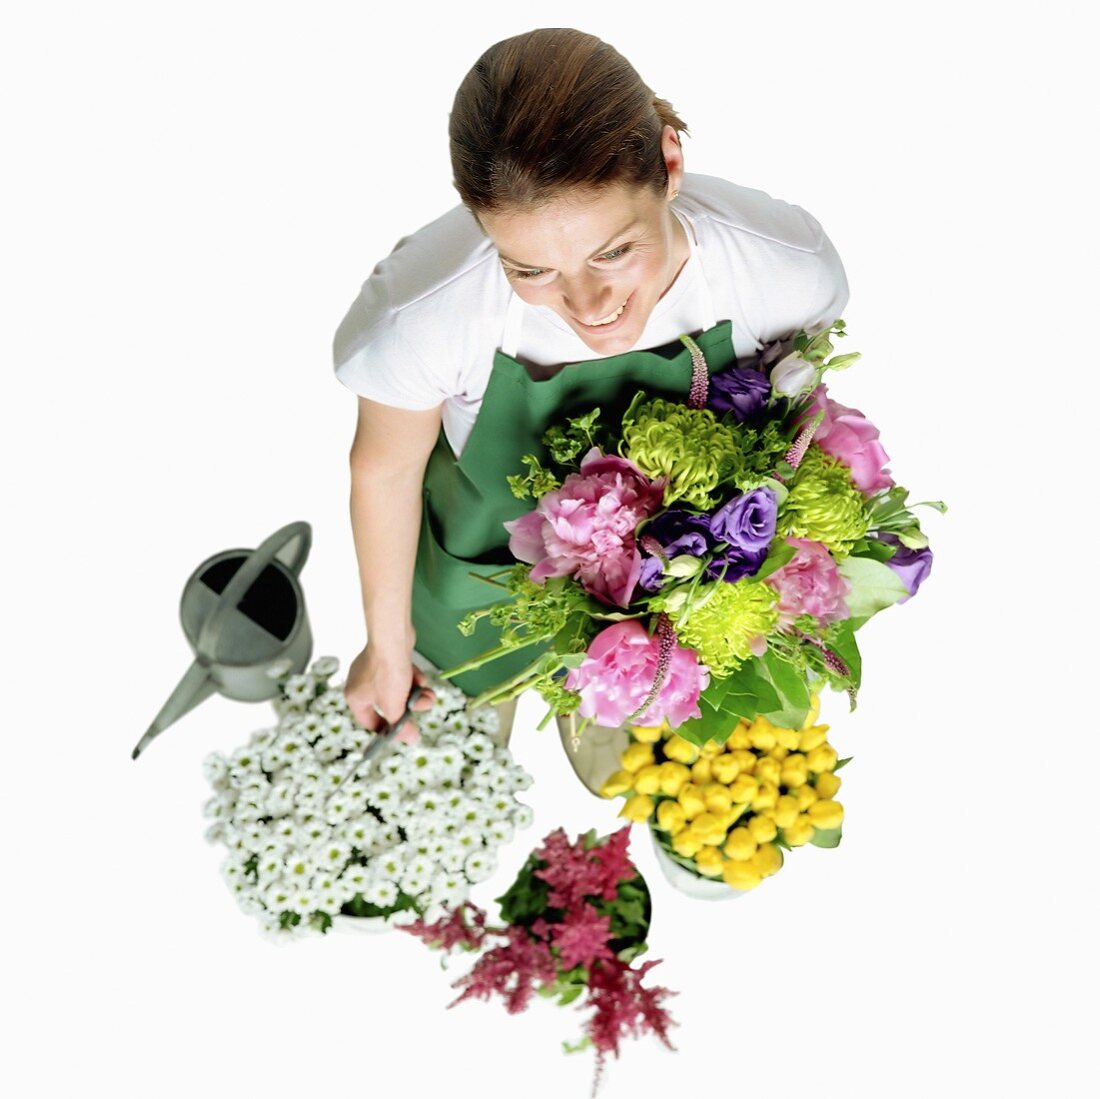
[677,580,779,677]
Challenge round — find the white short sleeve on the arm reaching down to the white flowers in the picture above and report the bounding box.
[332,268,453,411]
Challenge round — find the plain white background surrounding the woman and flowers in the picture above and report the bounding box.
[0,0,1100,1099]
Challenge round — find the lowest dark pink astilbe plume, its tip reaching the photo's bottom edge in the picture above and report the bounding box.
[585,958,677,1095]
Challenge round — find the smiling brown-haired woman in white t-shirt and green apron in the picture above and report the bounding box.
[334,29,848,792]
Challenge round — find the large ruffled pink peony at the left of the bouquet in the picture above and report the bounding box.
[504,447,664,607]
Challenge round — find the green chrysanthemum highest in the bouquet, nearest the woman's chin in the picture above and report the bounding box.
[620,397,741,510]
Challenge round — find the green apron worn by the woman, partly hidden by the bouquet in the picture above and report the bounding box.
[413,220,736,694]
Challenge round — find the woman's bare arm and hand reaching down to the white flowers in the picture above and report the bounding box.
[344,397,442,728]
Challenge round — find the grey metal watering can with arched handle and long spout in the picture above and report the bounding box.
[132,523,314,759]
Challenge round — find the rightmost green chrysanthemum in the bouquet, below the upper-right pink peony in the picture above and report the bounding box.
[777,446,869,558]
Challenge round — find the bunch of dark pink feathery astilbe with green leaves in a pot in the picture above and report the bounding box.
[404,828,674,1095]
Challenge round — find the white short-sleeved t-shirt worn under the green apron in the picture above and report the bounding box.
[333,173,848,454]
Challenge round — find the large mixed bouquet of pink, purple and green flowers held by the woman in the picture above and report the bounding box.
[444,320,944,745]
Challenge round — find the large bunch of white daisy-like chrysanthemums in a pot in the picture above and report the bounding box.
[202,657,531,942]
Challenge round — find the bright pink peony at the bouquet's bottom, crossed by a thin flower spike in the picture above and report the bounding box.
[565,618,711,728]
